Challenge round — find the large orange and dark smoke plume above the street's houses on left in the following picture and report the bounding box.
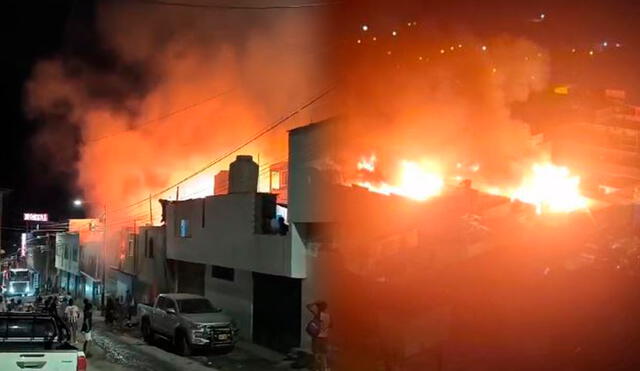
[26,3,326,218]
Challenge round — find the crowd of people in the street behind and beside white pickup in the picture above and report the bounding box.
[0,295,93,351]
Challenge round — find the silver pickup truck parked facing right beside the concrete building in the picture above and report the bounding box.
[138,294,238,355]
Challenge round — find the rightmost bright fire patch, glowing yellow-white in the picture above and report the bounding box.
[510,163,587,214]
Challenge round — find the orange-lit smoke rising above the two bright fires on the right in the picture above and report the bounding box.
[341,26,549,189]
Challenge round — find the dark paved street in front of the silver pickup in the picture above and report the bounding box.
[89,317,289,371]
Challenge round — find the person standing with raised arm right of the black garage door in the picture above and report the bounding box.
[307,301,331,371]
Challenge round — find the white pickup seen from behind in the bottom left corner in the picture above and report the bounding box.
[0,312,87,371]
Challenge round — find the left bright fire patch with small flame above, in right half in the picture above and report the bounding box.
[357,156,444,201]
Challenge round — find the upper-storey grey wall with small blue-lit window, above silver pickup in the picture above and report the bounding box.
[166,193,292,276]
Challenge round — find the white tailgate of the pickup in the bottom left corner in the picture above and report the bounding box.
[0,350,78,371]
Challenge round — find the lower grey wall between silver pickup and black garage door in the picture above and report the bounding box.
[205,265,253,341]
